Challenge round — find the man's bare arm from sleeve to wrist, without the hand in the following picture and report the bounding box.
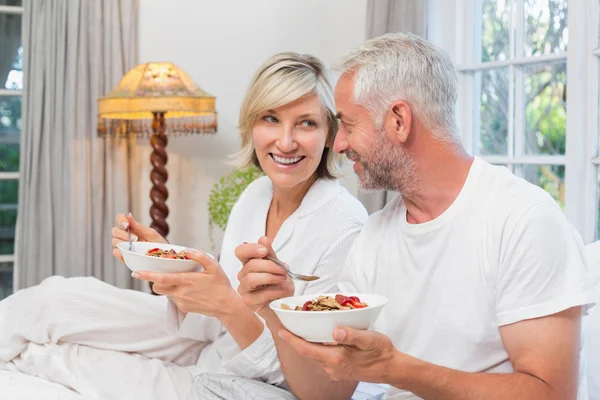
[389,307,581,400]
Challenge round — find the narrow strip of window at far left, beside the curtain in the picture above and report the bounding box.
[0,0,23,299]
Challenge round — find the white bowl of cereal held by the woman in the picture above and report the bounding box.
[117,242,202,272]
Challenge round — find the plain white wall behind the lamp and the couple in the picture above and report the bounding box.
[135,0,366,249]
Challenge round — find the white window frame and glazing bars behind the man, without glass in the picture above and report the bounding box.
[427,0,600,243]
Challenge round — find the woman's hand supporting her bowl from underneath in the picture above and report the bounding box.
[132,250,244,319]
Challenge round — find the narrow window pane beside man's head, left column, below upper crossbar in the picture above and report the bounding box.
[476,68,508,155]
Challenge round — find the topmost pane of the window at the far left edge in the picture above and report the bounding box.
[0,14,23,90]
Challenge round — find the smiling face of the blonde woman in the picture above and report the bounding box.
[252,94,329,188]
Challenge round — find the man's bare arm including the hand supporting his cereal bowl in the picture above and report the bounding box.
[284,307,581,400]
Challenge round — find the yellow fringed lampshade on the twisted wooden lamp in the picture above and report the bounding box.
[98,62,217,136]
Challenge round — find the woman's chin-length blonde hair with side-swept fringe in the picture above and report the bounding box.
[234,52,343,179]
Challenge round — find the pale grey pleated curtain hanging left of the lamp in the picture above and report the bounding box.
[15,0,138,290]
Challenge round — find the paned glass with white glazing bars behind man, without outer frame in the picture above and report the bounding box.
[457,0,569,205]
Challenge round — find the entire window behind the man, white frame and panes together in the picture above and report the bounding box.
[428,0,600,242]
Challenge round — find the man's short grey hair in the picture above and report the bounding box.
[337,33,458,141]
